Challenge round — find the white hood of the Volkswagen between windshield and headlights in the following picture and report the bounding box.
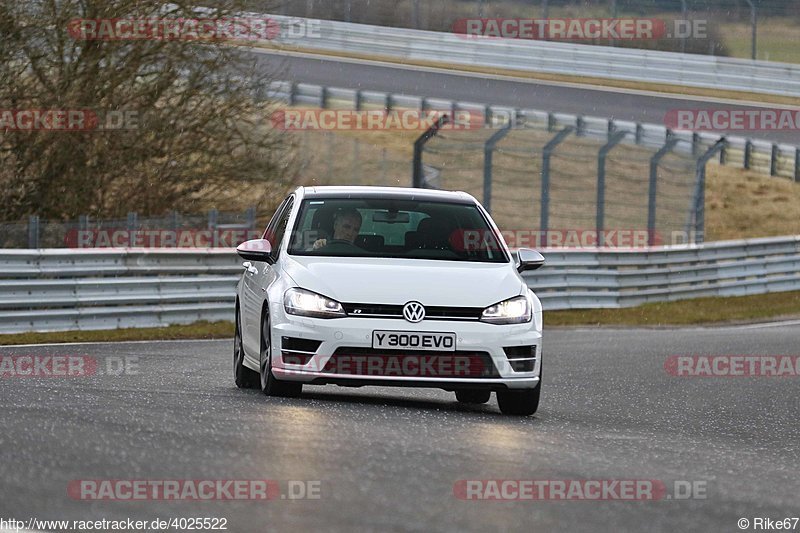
[284,255,525,307]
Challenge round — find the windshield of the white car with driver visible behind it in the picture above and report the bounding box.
[289,198,508,263]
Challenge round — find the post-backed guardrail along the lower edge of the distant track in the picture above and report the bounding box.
[268,81,800,182]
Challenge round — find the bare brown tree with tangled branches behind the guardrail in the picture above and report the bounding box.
[0,0,291,220]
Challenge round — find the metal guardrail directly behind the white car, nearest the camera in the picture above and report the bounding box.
[0,236,800,333]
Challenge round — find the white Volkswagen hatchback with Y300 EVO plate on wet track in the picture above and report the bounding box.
[233,187,544,415]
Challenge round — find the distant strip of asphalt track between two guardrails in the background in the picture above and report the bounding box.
[254,50,800,145]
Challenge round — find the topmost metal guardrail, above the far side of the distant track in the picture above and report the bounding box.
[270,15,800,96]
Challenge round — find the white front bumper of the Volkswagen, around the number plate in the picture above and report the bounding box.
[272,306,542,390]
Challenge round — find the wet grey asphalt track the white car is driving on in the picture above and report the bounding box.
[0,323,800,532]
